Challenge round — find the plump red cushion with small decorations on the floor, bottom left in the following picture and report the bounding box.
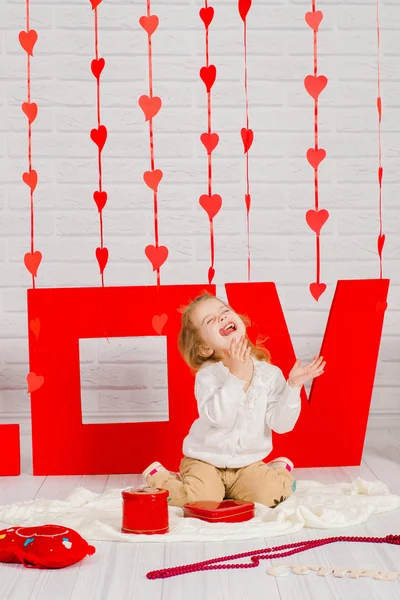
[0,525,96,569]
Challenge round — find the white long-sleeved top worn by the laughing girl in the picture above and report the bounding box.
[183,359,301,468]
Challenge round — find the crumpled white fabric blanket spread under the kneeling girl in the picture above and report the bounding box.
[0,478,400,542]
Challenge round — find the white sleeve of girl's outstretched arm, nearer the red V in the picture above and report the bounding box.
[265,368,301,433]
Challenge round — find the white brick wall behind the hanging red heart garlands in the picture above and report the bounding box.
[0,0,400,432]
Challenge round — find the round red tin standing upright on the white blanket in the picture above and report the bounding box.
[121,487,169,535]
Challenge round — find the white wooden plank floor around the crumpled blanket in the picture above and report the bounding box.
[0,429,400,600]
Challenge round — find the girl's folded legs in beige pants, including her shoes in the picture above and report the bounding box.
[147,456,294,508]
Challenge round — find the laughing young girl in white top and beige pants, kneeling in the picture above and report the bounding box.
[143,293,325,508]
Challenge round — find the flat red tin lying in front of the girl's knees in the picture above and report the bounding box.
[183,500,254,523]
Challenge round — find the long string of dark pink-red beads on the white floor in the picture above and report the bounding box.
[147,535,400,579]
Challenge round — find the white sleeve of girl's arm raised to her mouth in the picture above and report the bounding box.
[195,368,246,429]
